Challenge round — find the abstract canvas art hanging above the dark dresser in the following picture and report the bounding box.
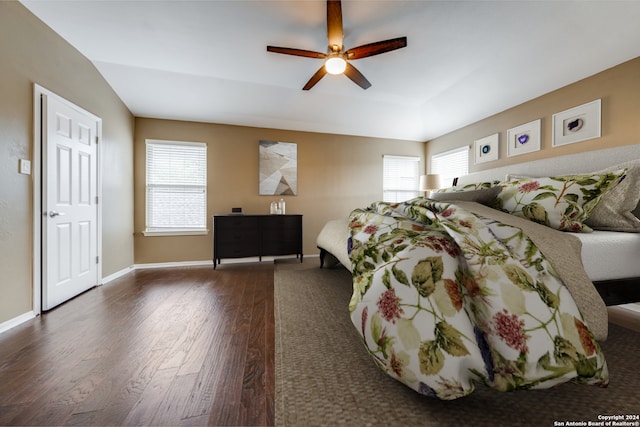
[259,141,298,196]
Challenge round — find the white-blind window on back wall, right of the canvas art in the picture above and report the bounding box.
[382,155,420,203]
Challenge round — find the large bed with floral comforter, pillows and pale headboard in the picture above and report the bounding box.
[317,145,640,399]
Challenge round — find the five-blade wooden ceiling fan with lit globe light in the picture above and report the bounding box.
[267,0,407,90]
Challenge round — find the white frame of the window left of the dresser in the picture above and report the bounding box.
[142,139,209,236]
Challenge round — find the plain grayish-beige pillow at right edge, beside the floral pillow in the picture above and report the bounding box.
[585,160,640,233]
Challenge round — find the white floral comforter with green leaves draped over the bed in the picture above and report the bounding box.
[349,198,608,399]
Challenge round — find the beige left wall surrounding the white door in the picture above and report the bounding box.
[0,1,134,323]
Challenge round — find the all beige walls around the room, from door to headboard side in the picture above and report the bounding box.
[5,1,640,323]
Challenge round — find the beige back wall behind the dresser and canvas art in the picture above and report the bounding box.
[134,118,424,264]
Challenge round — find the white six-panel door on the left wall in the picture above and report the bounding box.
[41,95,100,310]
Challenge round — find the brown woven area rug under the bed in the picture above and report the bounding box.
[274,258,640,427]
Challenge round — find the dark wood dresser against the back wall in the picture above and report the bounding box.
[213,214,302,269]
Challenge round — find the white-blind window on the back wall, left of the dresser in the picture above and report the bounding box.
[144,140,207,236]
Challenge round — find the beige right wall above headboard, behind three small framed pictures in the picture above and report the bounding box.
[426,58,640,176]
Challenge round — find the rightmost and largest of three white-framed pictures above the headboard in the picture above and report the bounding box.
[552,99,602,147]
